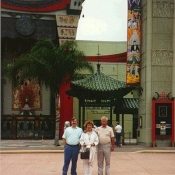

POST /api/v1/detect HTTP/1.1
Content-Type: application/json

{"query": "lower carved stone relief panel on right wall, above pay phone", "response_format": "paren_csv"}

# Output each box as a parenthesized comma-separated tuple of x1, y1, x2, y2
(152, 50, 173, 66)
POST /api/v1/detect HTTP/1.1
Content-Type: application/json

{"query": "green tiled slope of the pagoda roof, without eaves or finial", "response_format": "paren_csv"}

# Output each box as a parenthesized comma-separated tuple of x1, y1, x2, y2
(71, 72, 126, 92)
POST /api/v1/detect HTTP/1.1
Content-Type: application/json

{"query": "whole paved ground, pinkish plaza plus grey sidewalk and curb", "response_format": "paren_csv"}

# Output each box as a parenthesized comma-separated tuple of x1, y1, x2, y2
(0, 140, 175, 175)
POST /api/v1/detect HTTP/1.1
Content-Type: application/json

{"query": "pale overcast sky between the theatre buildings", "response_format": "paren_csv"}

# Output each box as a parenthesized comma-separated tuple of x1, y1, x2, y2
(76, 0, 127, 41)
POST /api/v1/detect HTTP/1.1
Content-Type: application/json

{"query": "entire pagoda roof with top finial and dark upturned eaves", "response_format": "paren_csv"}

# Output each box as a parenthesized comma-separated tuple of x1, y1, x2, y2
(66, 64, 135, 100)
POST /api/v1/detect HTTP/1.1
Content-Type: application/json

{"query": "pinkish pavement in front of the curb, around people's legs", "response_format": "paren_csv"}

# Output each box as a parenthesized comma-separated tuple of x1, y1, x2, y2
(0, 152, 175, 175)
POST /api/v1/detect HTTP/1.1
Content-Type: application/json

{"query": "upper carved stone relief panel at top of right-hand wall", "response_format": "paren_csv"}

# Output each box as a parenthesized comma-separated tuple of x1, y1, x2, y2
(153, 0, 174, 17)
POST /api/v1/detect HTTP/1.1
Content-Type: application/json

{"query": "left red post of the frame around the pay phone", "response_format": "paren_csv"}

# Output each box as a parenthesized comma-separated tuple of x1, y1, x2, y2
(152, 101, 156, 147)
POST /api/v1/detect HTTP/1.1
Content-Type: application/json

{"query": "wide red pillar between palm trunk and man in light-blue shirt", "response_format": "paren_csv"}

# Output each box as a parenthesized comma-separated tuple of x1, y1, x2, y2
(59, 83, 73, 139)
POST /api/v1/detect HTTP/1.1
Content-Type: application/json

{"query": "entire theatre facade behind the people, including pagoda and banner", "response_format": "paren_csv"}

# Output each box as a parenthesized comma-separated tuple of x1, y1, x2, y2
(1, 0, 175, 147)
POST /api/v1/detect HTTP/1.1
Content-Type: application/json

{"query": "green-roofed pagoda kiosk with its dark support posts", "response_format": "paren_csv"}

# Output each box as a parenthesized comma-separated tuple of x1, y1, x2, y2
(66, 63, 136, 126)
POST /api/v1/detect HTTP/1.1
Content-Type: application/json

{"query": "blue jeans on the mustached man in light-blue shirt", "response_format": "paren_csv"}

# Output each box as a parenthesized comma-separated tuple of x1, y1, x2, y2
(62, 145, 79, 175)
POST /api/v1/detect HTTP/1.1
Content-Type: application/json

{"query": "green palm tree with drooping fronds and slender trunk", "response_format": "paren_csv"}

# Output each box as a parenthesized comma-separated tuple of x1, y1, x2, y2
(3, 39, 93, 145)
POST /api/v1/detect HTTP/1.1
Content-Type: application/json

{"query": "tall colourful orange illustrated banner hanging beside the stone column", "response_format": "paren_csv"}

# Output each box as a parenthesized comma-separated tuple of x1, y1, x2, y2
(126, 0, 141, 84)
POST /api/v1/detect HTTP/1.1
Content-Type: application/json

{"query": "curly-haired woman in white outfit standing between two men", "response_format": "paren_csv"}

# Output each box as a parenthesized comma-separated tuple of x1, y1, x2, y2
(80, 121, 99, 175)
